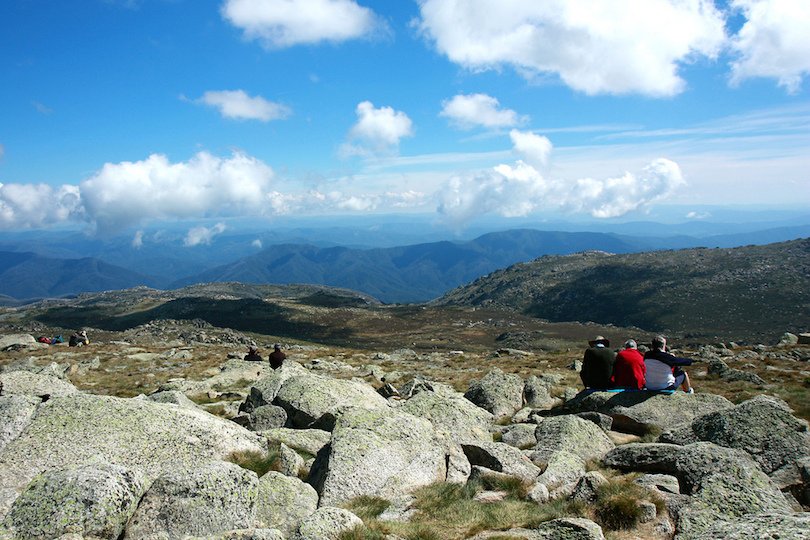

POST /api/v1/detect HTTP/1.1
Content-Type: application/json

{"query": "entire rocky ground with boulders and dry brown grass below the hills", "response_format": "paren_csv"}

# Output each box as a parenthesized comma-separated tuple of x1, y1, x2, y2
(0, 314, 810, 540)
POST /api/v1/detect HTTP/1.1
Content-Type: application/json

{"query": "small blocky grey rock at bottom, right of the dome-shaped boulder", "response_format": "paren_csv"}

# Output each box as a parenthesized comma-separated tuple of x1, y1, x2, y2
(255, 471, 318, 536)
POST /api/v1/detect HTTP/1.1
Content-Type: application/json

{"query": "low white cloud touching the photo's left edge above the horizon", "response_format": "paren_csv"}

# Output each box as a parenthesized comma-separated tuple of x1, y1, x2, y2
(0, 184, 83, 229)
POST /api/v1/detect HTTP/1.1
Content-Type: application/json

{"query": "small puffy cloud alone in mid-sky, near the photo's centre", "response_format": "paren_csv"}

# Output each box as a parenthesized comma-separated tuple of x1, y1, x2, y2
(343, 101, 413, 155)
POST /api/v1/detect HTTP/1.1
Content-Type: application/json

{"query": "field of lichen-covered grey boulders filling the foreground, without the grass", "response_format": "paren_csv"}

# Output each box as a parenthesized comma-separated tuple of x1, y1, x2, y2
(0, 350, 810, 540)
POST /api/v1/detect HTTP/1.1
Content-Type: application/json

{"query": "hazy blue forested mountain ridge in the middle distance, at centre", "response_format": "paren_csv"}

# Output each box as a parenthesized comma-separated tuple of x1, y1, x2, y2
(172, 229, 638, 302)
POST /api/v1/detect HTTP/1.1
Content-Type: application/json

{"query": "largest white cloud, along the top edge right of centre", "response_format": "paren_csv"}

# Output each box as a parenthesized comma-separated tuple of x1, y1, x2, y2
(419, 0, 726, 96)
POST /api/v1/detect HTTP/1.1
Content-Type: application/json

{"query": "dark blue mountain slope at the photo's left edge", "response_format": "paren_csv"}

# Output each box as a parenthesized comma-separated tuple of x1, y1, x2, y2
(0, 251, 158, 299)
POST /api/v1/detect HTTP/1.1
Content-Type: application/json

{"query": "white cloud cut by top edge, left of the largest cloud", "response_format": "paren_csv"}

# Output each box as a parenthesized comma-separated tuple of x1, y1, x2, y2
(222, 0, 384, 48)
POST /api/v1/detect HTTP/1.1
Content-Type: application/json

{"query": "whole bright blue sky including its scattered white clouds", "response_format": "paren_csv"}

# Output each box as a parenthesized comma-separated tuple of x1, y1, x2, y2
(0, 0, 810, 236)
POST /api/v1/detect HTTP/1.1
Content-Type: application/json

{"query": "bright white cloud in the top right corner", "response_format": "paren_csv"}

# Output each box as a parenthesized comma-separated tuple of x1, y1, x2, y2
(731, 0, 810, 93)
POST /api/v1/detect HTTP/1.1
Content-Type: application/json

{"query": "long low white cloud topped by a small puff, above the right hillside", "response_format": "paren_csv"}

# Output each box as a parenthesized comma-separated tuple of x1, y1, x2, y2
(438, 131, 684, 226)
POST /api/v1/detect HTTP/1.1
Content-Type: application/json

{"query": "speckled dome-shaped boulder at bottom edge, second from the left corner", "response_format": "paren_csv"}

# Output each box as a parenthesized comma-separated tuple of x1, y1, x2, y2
(125, 461, 259, 540)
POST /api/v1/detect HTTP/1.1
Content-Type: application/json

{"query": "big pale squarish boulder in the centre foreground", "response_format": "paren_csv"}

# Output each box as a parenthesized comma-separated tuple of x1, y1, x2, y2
(311, 408, 447, 506)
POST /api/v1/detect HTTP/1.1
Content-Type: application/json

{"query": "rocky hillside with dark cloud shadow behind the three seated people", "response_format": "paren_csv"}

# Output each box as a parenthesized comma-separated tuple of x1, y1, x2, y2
(437, 239, 810, 340)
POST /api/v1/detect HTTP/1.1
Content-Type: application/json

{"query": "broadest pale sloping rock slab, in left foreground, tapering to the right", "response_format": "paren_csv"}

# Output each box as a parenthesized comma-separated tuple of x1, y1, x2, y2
(0, 393, 266, 516)
